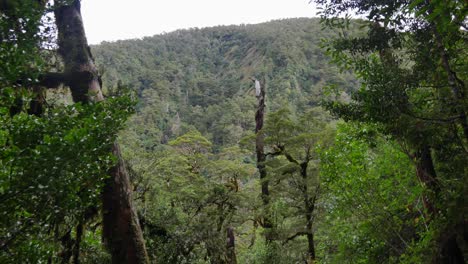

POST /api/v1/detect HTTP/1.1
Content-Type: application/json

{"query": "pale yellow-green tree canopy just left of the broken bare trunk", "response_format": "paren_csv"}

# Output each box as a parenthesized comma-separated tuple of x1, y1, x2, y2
(126, 130, 255, 263)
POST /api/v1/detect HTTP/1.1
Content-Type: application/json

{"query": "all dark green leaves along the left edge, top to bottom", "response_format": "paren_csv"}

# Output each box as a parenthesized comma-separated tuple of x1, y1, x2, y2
(0, 0, 135, 263)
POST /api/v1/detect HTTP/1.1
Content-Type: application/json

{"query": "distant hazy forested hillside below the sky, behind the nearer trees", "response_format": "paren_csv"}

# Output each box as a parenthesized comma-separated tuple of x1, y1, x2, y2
(92, 18, 357, 148)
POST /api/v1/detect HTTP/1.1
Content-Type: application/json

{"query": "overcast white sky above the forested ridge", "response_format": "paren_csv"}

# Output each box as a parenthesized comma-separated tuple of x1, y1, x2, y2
(81, 0, 316, 44)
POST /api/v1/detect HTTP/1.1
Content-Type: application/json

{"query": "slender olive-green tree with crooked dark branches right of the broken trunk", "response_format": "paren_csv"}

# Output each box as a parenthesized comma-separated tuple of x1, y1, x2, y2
(264, 108, 333, 263)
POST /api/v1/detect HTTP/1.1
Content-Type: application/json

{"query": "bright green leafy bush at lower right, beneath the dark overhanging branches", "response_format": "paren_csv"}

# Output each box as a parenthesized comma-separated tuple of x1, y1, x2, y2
(318, 123, 428, 263)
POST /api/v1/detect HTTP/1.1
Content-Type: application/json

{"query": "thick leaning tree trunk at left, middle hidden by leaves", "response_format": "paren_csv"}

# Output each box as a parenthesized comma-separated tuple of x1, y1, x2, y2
(55, 0, 149, 263)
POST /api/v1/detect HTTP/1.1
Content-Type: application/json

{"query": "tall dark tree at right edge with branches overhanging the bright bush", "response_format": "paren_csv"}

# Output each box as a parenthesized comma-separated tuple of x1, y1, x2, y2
(315, 0, 468, 263)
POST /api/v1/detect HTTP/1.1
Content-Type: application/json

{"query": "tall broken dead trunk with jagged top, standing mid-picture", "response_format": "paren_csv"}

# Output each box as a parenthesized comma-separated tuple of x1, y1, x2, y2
(254, 80, 273, 243)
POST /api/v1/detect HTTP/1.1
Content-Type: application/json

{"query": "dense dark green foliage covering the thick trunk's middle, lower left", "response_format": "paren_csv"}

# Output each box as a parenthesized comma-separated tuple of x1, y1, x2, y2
(0, 88, 132, 262)
